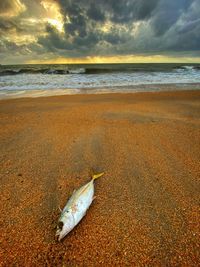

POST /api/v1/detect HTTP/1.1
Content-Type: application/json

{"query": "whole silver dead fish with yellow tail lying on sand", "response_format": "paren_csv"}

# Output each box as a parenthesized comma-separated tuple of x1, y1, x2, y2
(56, 173, 104, 241)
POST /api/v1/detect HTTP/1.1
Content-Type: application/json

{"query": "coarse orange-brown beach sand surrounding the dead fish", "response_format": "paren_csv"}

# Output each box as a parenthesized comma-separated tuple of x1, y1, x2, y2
(0, 91, 200, 266)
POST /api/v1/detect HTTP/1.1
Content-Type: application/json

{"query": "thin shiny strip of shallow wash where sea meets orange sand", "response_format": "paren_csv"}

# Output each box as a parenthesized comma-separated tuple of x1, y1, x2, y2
(0, 83, 200, 101)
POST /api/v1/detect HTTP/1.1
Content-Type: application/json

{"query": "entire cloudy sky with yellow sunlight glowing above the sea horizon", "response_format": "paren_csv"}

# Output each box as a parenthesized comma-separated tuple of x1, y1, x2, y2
(0, 0, 200, 64)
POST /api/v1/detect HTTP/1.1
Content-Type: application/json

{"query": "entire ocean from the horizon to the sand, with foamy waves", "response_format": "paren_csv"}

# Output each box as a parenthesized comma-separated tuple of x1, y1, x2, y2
(0, 63, 200, 99)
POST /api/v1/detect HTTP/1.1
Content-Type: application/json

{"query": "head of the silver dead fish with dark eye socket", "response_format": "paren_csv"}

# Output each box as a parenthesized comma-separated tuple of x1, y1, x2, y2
(56, 211, 75, 241)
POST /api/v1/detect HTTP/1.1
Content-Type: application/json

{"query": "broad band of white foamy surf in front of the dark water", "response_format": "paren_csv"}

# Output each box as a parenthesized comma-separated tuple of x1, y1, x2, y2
(0, 66, 200, 98)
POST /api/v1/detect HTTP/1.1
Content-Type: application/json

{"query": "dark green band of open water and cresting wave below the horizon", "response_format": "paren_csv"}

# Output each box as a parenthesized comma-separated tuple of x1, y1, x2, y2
(0, 64, 200, 76)
